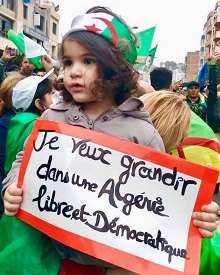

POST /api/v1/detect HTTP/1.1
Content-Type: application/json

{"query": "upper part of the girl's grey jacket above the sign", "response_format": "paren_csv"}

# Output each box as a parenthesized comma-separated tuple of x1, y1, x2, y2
(42, 98, 164, 151)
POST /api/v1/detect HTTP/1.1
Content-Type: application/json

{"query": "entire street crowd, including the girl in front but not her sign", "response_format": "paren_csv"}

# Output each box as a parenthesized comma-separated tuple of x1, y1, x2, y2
(0, 6, 220, 275)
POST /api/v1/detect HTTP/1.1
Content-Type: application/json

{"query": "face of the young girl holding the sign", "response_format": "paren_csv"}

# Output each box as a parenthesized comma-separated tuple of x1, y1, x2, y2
(62, 40, 99, 103)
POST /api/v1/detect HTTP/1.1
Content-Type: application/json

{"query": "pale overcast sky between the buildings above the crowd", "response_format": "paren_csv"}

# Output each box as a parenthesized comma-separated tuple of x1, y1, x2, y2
(53, 0, 217, 65)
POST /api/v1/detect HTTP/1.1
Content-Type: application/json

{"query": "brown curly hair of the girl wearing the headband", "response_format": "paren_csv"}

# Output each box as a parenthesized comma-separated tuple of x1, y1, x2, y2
(54, 7, 139, 105)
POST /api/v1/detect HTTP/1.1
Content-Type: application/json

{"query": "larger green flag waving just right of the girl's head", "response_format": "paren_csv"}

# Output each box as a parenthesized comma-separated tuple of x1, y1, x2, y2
(136, 26, 156, 59)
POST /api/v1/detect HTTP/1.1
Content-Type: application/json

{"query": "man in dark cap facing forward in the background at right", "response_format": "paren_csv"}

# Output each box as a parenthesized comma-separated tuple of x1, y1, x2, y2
(186, 81, 207, 122)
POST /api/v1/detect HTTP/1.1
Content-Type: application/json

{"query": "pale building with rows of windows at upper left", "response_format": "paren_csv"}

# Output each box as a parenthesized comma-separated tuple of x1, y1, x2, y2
(0, 0, 60, 59)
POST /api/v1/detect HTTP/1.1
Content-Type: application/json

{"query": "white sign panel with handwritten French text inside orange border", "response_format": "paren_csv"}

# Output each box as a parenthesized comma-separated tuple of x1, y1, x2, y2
(17, 121, 218, 272)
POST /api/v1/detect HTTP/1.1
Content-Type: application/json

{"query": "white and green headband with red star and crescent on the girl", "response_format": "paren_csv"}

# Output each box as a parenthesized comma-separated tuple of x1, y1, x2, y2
(64, 13, 137, 64)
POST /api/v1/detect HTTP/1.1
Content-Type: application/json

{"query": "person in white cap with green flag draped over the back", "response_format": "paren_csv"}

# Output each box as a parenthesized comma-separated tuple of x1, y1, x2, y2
(4, 70, 55, 177)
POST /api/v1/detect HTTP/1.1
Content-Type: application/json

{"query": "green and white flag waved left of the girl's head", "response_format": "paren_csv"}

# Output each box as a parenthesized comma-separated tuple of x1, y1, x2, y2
(7, 29, 47, 69)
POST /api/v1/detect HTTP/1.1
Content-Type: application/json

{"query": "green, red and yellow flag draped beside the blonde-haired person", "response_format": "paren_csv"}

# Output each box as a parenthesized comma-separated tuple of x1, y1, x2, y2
(172, 111, 220, 182)
